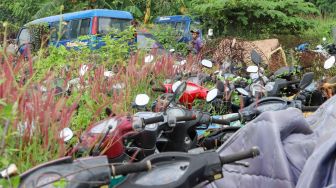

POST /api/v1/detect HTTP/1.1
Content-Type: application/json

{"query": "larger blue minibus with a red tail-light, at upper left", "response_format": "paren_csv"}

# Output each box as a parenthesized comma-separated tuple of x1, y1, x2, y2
(17, 9, 133, 53)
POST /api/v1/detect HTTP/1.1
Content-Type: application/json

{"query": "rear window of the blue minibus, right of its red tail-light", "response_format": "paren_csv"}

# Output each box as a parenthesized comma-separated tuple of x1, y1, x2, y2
(98, 18, 131, 34)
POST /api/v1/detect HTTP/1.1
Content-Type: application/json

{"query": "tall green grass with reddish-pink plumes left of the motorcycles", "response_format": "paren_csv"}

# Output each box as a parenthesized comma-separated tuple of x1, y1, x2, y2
(0, 40, 193, 176)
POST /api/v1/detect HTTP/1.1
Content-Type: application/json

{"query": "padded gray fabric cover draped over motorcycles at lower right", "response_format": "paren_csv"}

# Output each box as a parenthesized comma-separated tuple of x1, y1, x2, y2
(207, 97, 336, 188)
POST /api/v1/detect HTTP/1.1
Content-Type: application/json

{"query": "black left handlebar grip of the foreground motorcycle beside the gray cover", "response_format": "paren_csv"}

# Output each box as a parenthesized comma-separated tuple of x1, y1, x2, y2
(111, 160, 152, 176)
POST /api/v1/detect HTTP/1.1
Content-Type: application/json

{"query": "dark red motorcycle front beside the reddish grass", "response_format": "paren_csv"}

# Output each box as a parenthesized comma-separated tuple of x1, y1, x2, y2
(68, 112, 163, 161)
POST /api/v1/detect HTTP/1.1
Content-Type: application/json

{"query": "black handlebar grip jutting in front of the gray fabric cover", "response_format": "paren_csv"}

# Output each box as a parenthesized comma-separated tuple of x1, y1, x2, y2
(220, 146, 260, 165)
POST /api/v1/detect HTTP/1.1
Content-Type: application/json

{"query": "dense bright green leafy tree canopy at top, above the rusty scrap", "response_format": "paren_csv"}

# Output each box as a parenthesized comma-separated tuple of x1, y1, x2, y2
(192, 0, 318, 36)
